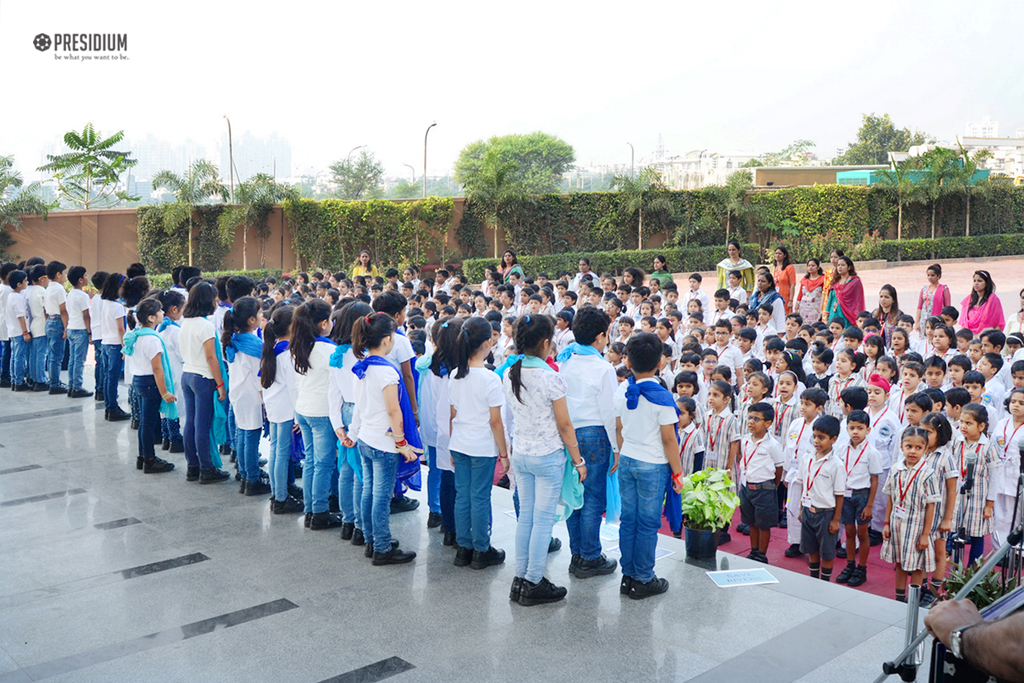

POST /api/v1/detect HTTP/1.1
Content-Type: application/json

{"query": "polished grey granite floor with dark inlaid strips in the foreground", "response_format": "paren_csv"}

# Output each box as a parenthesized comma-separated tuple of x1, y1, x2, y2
(0, 390, 927, 683)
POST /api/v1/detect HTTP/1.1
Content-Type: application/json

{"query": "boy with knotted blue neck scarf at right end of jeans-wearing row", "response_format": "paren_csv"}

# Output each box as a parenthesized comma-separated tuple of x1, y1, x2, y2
(614, 333, 683, 600)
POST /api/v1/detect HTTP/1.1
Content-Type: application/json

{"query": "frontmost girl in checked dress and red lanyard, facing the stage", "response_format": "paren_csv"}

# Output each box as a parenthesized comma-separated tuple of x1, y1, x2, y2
(882, 427, 939, 602)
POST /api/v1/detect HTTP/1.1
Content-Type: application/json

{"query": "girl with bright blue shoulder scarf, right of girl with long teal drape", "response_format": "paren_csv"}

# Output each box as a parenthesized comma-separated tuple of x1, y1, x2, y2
(221, 296, 270, 496)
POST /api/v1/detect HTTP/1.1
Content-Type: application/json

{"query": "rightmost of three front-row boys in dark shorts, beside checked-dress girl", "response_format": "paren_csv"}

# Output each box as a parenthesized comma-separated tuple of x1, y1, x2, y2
(836, 410, 882, 586)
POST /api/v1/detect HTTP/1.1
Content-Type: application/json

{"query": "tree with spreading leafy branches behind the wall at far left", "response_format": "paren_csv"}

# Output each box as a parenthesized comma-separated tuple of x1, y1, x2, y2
(38, 123, 139, 211)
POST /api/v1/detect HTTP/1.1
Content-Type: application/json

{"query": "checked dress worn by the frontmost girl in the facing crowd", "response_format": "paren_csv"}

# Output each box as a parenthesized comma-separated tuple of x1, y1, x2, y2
(882, 457, 939, 571)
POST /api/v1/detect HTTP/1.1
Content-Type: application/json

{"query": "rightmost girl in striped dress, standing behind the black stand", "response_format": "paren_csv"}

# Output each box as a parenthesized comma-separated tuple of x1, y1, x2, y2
(953, 403, 1000, 564)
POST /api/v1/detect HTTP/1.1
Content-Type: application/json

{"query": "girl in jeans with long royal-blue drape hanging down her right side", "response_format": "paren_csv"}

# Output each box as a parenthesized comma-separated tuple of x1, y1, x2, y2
(347, 313, 423, 565)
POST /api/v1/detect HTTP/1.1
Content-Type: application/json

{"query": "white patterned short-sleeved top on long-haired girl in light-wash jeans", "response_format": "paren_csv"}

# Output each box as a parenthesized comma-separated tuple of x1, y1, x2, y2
(502, 368, 567, 458)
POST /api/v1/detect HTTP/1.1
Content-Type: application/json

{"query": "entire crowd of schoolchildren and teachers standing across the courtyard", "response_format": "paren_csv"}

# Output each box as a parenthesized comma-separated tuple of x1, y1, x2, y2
(0, 243, 1024, 605)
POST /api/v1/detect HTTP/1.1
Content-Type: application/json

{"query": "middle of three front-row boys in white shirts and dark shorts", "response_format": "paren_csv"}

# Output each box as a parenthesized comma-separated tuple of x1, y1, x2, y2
(797, 415, 846, 581)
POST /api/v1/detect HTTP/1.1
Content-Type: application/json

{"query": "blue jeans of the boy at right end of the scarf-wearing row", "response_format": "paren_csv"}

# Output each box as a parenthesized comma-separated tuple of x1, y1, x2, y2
(614, 456, 670, 584)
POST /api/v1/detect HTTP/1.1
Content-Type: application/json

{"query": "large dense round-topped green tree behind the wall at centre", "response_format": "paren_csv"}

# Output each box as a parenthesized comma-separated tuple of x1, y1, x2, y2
(455, 131, 575, 195)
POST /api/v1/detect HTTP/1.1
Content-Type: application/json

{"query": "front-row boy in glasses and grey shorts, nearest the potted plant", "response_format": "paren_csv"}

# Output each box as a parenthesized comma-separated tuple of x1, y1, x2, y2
(737, 401, 783, 564)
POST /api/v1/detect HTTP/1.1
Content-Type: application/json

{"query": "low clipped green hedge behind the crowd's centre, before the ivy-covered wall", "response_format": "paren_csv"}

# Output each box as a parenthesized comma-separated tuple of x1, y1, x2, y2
(462, 244, 761, 283)
